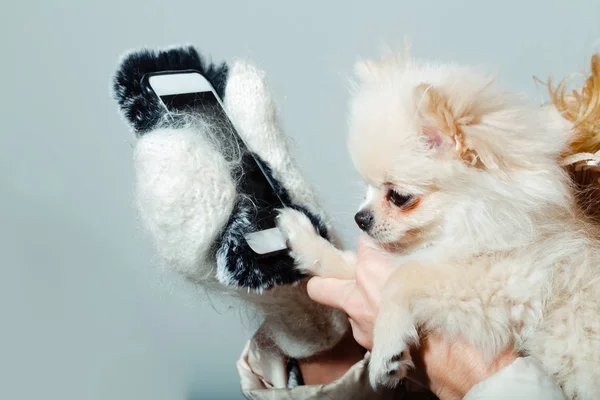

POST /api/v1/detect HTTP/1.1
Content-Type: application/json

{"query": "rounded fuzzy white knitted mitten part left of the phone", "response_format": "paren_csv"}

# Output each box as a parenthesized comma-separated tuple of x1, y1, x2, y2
(134, 128, 236, 283)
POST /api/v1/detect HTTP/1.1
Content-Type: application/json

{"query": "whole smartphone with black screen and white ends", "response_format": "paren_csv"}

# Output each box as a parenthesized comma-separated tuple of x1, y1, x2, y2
(143, 70, 287, 256)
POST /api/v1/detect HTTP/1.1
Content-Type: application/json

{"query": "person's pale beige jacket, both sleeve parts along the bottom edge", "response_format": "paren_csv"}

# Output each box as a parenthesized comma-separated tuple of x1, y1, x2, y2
(237, 330, 564, 400)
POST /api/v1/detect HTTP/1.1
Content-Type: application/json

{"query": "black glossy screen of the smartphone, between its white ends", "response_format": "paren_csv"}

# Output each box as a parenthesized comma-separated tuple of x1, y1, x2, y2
(160, 91, 284, 230)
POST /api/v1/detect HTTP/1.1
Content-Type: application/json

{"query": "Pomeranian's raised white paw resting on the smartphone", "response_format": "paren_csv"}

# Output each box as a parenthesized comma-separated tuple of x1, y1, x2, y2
(277, 208, 323, 273)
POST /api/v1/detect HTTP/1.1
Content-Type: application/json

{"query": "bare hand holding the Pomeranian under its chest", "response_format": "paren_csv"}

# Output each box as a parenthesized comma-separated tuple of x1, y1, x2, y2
(307, 237, 518, 400)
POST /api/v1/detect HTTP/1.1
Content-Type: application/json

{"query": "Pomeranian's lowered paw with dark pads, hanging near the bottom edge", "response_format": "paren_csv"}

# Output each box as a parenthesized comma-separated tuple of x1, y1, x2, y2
(369, 343, 414, 389)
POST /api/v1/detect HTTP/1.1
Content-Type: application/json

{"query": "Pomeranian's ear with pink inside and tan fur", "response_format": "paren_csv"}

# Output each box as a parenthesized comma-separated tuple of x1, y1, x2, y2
(414, 83, 496, 168)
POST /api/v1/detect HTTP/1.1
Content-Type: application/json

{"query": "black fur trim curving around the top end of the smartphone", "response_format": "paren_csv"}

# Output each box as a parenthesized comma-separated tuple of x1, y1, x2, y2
(113, 46, 228, 135)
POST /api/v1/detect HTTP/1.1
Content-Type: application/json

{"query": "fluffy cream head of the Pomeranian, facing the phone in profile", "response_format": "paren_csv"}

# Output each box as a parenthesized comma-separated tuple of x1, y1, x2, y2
(349, 51, 572, 252)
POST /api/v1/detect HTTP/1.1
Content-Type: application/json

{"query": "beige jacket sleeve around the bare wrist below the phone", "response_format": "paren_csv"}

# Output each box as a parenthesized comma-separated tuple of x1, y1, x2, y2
(237, 332, 434, 400)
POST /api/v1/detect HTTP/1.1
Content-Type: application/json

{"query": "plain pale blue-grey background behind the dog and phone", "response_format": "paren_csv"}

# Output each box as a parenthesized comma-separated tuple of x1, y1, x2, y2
(0, 0, 600, 400)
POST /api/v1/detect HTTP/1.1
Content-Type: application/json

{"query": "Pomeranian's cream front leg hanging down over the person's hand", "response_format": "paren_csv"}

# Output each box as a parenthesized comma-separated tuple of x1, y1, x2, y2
(369, 263, 515, 387)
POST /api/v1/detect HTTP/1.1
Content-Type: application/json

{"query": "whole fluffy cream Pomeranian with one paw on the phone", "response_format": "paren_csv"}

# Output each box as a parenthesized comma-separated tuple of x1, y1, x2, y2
(279, 51, 600, 399)
